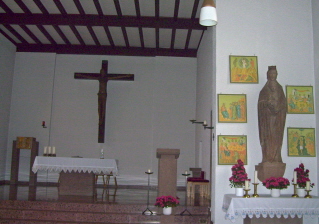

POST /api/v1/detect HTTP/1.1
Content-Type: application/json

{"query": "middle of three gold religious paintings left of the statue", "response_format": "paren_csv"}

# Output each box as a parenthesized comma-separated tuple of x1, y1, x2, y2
(218, 94, 247, 123)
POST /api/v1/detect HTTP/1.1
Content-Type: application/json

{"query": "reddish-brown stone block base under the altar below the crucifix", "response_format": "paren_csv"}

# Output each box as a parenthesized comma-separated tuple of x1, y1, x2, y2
(59, 171, 95, 196)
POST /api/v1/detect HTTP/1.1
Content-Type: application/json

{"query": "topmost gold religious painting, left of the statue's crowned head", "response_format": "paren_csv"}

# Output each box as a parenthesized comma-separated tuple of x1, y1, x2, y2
(229, 55, 258, 83)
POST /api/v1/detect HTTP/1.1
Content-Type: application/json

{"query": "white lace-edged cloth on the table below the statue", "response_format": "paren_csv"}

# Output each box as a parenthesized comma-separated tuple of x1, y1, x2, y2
(223, 194, 319, 222)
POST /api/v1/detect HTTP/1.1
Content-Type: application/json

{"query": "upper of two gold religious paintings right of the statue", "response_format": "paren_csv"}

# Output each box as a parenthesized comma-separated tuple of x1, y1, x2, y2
(286, 86, 315, 114)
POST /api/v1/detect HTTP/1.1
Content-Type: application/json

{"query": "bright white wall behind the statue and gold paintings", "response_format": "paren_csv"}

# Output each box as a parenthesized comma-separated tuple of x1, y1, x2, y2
(213, 0, 318, 224)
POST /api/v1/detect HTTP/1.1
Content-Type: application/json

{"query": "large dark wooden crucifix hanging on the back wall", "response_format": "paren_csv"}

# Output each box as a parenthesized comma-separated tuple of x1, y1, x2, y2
(74, 60, 134, 143)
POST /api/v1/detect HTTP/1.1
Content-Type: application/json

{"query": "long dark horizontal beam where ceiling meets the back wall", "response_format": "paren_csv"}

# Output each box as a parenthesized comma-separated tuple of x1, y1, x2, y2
(16, 44, 197, 57)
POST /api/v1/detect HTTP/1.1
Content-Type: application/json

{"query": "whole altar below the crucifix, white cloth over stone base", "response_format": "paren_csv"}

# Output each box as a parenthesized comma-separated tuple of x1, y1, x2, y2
(32, 156, 118, 196)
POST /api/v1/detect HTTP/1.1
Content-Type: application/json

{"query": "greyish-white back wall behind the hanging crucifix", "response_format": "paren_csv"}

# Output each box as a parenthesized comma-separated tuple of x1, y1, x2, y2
(7, 53, 196, 185)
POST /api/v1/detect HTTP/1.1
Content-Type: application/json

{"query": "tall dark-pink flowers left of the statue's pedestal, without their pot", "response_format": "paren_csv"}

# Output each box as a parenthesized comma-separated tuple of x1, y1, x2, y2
(229, 159, 250, 187)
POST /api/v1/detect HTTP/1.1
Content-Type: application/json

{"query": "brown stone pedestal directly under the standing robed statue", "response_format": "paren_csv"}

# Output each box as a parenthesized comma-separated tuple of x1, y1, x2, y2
(255, 162, 286, 181)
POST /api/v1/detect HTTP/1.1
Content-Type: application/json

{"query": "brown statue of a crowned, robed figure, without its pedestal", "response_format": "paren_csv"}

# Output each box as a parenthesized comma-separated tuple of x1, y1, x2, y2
(258, 66, 287, 163)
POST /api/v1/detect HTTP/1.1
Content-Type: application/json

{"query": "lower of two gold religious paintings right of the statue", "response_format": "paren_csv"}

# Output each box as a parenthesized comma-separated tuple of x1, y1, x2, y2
(287, 128, 316, 157)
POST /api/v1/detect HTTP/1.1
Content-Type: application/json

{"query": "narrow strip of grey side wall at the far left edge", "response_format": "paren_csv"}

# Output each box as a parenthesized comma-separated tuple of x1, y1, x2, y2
(0, 34, 16, 180)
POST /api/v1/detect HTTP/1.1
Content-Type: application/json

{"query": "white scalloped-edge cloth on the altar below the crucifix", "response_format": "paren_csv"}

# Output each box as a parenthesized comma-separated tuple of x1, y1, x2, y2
(32, 156, 118, 176)
